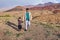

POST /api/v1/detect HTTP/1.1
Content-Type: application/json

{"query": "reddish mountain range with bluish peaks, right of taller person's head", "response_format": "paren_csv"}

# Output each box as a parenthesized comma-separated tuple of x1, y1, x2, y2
(30, 2, 60, 10)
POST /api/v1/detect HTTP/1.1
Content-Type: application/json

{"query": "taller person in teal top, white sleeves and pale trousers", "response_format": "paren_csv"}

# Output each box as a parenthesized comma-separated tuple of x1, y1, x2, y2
(24, 8, 32, 31)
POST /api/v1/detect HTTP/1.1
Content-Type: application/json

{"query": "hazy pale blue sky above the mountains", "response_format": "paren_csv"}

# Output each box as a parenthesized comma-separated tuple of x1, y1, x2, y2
(0, 0, 60, 9)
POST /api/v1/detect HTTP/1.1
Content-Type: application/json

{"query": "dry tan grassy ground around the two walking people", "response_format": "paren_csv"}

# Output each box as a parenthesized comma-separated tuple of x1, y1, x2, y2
(0, 10, 60, 40)
